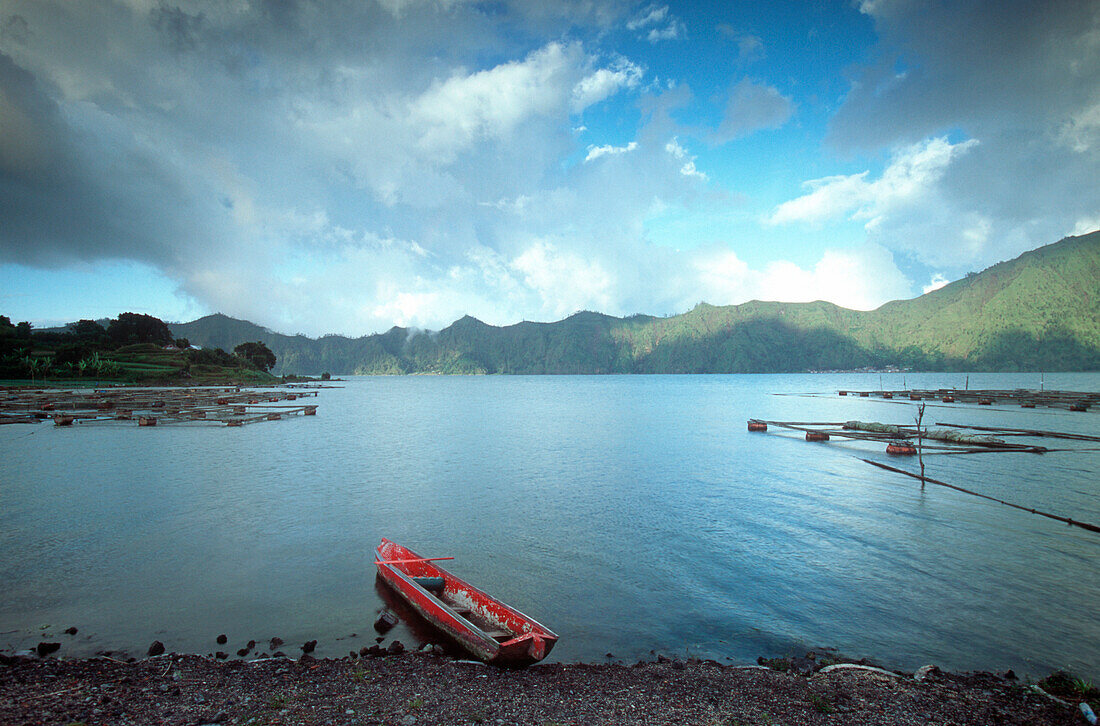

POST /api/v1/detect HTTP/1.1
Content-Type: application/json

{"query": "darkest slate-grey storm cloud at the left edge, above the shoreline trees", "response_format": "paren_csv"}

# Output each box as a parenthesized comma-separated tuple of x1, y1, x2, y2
(0, 48, 228, 266)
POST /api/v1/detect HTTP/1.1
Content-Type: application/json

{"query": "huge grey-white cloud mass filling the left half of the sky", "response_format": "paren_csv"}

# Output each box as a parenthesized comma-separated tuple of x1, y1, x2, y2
(0, 0, 684, 329)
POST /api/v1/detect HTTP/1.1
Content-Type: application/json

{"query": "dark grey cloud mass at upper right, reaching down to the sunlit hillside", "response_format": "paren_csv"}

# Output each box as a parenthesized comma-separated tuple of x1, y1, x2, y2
(828, 0, 1100, 268)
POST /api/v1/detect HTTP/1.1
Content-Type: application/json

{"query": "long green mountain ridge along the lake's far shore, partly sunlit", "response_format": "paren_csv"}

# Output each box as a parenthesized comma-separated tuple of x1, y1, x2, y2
(171, 232, 1100, 374)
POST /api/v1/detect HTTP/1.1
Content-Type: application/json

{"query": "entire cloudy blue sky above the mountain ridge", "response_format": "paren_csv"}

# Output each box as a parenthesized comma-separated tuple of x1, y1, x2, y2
(0, 0, 1100, 337)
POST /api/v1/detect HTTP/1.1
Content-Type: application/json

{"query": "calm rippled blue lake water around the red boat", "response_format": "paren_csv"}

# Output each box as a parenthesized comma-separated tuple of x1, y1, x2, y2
(0, 374, 1100, 679)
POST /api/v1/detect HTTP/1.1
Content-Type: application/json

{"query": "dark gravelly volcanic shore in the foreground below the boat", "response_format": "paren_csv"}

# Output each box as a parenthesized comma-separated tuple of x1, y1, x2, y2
(0, 653, 1085, 726)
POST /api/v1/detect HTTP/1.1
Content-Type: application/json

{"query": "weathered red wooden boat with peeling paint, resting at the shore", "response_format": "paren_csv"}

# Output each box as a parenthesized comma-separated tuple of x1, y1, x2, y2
(375, 538, 558, 667)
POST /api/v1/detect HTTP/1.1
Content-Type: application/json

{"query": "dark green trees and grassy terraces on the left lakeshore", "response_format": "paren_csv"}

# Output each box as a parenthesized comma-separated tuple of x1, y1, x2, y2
(0, 312, 275, 385)
